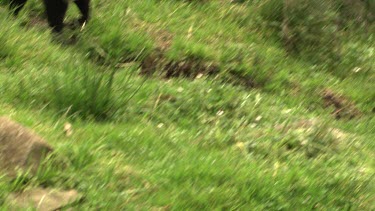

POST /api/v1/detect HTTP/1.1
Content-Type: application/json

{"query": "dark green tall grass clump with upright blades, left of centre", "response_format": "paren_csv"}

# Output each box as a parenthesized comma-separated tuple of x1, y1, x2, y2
(47, 66, 144, 121)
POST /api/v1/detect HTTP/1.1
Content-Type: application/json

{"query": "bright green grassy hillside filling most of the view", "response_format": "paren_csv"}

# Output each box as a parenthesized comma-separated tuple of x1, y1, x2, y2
(0, 0, 375, 210)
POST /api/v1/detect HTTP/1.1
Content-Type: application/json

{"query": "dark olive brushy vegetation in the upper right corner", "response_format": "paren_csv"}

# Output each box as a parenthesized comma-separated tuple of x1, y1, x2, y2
(256, 0, 374, 74)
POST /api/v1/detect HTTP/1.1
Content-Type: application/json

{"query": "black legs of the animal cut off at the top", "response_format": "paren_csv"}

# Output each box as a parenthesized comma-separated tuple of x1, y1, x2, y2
(10, 0, 90, 32)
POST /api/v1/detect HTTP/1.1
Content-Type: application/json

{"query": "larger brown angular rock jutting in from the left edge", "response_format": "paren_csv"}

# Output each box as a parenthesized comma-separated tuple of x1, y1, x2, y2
(0, 117, 52, 177)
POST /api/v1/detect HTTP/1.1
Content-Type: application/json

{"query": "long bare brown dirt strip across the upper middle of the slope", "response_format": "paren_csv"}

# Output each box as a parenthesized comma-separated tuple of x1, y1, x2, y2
(121, 15, 263, 88)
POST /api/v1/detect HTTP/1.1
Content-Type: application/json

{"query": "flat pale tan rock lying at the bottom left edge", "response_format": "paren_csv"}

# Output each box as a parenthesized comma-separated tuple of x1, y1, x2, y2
(5, 188, 82, 211)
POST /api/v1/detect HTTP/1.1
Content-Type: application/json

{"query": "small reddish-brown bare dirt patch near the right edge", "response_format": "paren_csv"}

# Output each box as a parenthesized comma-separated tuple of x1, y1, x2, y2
(321, 89, 361, 119)
